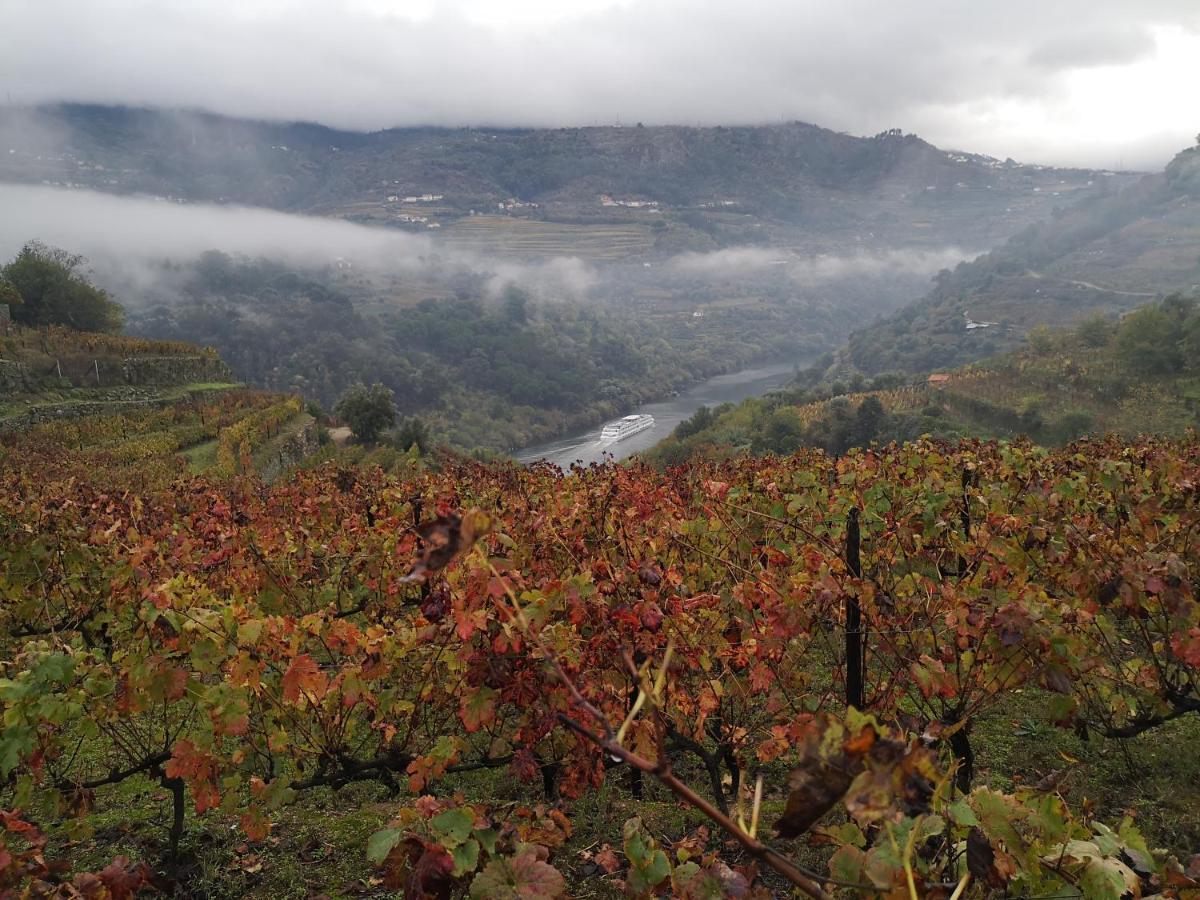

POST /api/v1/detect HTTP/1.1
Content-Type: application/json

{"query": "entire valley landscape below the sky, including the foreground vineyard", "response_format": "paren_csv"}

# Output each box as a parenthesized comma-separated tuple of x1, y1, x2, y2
(0, 90, 1200, 900)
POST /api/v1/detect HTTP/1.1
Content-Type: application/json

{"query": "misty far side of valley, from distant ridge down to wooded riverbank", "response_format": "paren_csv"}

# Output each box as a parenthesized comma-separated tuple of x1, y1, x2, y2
(0, 104, 1152, 452)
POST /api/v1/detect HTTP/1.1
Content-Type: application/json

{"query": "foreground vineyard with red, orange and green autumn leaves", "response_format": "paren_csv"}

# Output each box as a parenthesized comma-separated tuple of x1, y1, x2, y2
(0, 438, 1200, 900)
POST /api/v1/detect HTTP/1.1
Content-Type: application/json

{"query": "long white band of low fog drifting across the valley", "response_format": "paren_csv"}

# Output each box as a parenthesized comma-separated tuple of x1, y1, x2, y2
(0, 184, 968, 312)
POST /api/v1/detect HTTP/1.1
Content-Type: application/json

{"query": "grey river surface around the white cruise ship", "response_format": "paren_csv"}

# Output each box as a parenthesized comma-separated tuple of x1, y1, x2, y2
(515, 361, 803, 469)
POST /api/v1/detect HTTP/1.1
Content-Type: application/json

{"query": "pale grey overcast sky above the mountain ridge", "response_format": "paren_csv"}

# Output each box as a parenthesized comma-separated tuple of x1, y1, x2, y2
(0, 0, 1200, 168)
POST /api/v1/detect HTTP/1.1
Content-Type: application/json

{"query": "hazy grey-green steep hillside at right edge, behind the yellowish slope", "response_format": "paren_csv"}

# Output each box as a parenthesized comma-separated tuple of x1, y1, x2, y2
(845, 148, 1200, 374)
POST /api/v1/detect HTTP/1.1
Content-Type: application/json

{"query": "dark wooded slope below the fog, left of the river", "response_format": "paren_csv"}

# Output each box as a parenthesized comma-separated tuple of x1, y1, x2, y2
(121, 253, 842, 450)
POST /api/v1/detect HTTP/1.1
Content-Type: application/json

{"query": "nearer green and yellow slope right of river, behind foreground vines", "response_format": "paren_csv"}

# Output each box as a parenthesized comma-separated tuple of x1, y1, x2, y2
(647, 294, 1200, 464)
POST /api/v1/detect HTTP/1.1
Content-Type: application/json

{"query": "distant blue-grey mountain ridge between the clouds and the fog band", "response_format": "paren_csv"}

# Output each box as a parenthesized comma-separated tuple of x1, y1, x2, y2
(0, 104, 1129, 252)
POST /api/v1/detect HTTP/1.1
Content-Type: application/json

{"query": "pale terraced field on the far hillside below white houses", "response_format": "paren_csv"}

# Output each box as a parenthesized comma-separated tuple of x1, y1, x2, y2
(442, 216, 654, 259)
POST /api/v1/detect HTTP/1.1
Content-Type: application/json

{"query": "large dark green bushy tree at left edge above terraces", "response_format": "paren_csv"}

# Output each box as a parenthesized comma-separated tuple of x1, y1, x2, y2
(0, 241, 125, 331)
